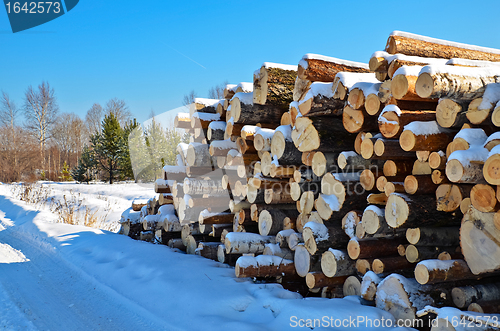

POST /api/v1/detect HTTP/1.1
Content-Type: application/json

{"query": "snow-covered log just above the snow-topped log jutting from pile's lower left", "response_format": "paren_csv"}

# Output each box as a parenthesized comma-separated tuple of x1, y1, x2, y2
(224, 232, 276, 254)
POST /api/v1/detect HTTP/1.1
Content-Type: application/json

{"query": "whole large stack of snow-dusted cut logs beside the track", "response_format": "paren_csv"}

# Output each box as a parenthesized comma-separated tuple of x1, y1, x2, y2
(122, 32, 500, 330)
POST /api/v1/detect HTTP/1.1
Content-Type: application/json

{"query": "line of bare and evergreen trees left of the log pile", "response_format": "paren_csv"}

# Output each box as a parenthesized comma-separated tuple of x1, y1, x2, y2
(0, 82, 187, 183)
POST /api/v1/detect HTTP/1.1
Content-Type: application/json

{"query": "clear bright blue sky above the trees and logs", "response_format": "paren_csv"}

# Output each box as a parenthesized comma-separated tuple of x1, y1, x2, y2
(0, 0, 500, 122)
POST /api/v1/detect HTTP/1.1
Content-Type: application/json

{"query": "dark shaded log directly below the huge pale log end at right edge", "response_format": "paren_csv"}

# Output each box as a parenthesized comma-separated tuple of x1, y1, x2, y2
(451, 283, 500, 308)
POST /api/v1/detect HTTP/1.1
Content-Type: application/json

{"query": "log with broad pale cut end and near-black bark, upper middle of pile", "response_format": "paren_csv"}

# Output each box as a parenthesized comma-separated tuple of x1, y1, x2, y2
(292, 116, 355, 152)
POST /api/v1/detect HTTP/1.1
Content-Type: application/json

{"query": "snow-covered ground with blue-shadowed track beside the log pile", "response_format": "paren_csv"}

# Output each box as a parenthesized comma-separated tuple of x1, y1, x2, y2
(0, 183, 418, 331)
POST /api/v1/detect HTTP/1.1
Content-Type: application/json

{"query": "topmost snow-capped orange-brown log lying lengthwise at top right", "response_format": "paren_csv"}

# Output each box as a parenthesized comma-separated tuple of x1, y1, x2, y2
(385, 31, 500, 61)
